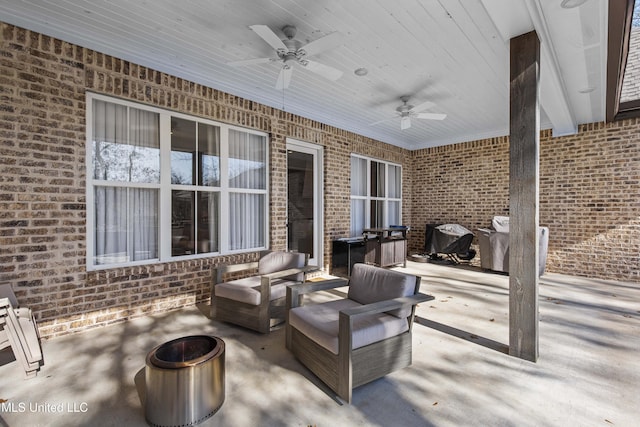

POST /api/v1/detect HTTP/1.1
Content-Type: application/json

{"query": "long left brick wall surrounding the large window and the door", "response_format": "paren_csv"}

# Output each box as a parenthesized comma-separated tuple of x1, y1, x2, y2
(0, 23, 406, 337)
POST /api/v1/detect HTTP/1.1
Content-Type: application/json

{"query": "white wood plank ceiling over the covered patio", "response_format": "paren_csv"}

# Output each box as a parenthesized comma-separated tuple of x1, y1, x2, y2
(0, 0, 608, 149)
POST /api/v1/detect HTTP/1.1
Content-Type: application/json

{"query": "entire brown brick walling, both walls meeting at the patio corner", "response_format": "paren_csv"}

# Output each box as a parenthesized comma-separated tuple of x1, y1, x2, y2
(0, 23, 640, 337)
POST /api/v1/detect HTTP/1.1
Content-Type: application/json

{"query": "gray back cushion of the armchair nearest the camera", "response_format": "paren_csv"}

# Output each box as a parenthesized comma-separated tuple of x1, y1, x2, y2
(348, 264, 416, 317)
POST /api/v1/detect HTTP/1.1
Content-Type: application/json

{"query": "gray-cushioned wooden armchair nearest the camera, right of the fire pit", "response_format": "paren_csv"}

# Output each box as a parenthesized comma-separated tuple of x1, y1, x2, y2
(286, 264, 433, 403)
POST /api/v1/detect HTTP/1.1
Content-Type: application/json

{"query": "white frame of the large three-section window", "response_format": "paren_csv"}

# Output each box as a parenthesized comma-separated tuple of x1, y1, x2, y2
(85, 92, 270, 271)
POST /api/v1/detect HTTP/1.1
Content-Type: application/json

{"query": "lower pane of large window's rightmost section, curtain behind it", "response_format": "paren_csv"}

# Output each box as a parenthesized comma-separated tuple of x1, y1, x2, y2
(229, 193, 265, 250)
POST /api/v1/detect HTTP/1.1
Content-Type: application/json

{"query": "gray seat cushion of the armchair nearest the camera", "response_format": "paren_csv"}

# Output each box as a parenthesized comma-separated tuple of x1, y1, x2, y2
(289, 298, 409, 354)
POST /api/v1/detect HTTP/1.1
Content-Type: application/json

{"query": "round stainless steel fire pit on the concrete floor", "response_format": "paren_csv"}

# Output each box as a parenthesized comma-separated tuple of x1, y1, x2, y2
(145, 335, 225, 427)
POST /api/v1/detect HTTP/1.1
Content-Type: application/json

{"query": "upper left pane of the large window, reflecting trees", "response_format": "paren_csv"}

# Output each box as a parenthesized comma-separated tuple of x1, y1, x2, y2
(92, 100, 160, 183)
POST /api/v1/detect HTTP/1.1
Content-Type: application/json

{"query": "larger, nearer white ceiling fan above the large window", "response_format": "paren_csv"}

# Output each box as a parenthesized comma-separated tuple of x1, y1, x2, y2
(227, 25, 342, 89)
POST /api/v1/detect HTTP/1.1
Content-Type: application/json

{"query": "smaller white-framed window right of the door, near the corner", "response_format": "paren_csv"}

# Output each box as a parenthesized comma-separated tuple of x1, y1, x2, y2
(351, 155, 402, 236)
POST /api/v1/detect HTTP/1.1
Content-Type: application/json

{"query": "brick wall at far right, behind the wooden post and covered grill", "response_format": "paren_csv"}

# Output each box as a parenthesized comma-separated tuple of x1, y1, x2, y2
(410, 125, 640, 282)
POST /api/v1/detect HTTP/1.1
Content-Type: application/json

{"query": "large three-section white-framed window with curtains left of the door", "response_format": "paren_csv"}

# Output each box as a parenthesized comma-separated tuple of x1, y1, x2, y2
(87, 94, 268, 269)
